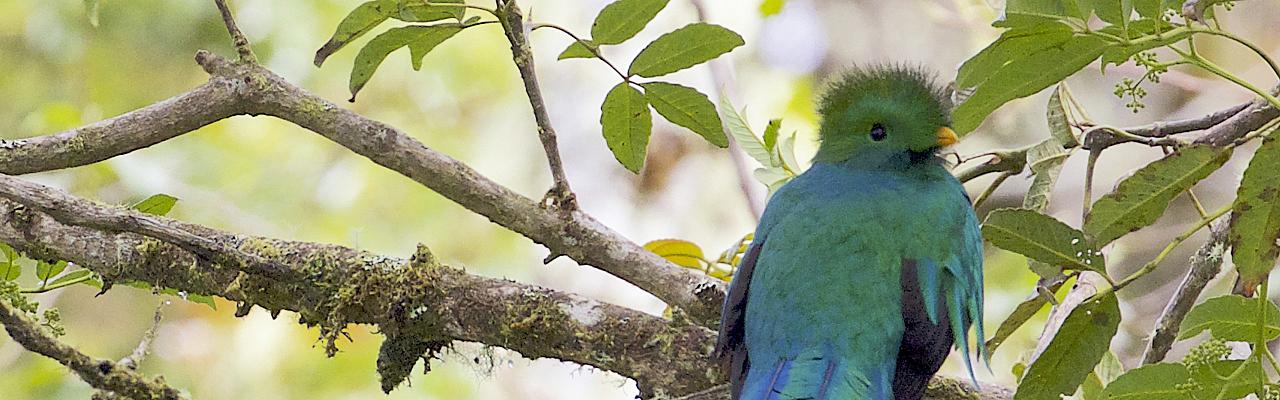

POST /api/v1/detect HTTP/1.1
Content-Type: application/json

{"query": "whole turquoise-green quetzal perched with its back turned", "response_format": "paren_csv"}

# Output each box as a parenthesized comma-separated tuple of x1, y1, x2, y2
(716, 67, 986, 400)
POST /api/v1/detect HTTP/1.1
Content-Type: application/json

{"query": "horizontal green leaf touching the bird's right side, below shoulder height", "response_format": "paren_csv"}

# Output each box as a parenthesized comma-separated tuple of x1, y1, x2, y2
(982, 209, 1106, 276)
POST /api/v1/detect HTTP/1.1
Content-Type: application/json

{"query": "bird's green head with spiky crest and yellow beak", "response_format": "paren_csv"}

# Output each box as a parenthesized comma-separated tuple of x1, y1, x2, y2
(814, 67, 956, 163)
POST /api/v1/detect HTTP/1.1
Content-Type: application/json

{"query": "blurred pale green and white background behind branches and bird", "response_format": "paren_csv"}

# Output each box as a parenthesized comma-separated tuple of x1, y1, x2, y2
(0, 0, 1280, 399)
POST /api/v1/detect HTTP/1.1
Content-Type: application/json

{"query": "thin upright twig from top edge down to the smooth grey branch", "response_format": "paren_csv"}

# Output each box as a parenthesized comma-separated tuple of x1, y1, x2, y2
(497, 0, 577, 211)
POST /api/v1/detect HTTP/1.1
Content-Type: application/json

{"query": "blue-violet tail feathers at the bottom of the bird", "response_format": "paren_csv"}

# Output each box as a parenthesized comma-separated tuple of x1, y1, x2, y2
(740, 353, 893, 400)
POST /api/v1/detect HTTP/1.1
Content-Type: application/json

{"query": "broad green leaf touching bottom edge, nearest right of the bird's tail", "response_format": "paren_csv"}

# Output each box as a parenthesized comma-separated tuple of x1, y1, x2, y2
(1014, 292, 1120, 400)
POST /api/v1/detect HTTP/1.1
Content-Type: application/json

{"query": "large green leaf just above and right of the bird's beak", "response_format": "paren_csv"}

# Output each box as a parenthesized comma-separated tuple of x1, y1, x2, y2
(952, 24, 1107, 133)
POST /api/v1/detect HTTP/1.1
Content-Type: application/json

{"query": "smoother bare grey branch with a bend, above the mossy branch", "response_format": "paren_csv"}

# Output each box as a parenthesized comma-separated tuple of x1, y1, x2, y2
(0, 51, 724, 326)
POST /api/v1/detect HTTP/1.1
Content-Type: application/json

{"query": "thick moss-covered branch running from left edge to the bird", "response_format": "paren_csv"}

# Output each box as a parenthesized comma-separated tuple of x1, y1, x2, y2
(0, 178, 723, 394)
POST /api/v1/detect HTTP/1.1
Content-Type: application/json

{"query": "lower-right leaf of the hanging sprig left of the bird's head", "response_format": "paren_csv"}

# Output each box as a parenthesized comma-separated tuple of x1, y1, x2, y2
(640, 82, 728, 147)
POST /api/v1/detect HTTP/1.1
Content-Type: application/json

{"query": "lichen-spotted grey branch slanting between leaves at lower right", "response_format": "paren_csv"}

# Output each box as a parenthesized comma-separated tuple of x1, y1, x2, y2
(1142, 215, 1231, 364)
